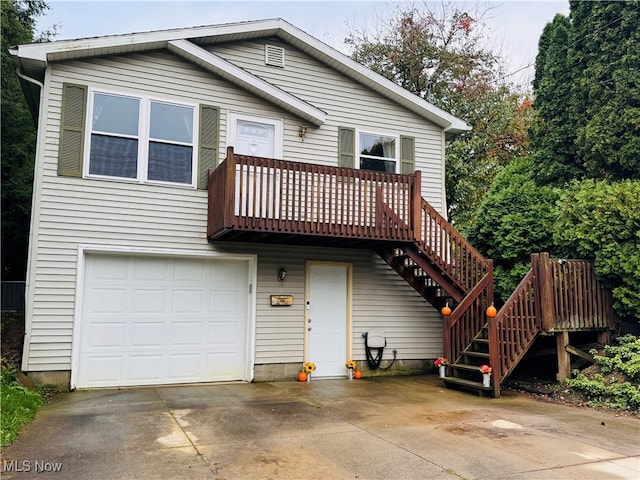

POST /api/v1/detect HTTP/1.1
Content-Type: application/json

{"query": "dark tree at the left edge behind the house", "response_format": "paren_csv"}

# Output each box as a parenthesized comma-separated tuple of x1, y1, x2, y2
(0, 0, 52, 280)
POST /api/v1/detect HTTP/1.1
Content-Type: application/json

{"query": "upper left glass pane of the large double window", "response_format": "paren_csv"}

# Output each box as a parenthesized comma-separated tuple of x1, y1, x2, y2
(92, 93, 140, 136)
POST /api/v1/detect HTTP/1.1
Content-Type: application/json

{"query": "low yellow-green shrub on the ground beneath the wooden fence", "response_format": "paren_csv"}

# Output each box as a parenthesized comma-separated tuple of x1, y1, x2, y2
(567, 335, 640, 410)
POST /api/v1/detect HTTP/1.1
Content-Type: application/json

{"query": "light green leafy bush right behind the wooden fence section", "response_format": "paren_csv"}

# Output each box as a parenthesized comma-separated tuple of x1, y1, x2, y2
(554, 180, 640, 320)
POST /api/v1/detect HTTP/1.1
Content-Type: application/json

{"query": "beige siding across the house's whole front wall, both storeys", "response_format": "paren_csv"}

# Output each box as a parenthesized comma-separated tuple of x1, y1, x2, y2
(23, 42, 442, 378)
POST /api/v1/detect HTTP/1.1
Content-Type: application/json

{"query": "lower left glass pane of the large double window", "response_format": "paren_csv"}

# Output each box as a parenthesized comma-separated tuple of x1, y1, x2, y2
(89, 134, 138, 178)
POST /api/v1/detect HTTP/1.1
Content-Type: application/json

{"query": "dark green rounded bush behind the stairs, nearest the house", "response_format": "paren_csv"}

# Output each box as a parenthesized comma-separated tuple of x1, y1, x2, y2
(468, 157, 558, 301)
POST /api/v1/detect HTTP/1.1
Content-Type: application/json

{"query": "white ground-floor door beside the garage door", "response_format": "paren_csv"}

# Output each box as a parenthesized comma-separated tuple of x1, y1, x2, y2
(307, 264, 348, 377)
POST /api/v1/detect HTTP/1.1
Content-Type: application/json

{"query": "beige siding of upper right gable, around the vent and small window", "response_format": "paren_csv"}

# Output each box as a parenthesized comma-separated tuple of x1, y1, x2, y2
(209, 39, 444, 213)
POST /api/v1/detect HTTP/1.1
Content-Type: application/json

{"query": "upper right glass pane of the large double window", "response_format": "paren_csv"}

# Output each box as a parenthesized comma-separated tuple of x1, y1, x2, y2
(149, 102, 193, 143)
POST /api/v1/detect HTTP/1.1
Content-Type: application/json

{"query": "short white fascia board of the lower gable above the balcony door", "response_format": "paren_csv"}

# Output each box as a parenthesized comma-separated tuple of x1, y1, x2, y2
(167, 40, 326, 127)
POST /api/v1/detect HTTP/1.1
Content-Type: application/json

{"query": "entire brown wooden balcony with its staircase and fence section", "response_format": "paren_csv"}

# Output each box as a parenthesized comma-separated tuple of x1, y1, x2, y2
(207, 153, 613, 396)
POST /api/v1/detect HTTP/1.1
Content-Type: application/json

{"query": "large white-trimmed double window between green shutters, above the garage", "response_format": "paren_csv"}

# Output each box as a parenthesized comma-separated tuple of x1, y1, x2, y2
(85, 92, 197, 185)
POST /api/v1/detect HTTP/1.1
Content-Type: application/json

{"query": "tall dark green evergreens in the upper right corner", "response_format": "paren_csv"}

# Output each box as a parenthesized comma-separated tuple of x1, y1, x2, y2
(531, 0, 640, 185)
